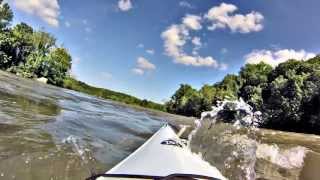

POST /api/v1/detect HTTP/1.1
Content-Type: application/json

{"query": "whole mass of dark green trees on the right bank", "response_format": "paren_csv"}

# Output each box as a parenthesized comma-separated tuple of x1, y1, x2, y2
(166, 56, 320, 134)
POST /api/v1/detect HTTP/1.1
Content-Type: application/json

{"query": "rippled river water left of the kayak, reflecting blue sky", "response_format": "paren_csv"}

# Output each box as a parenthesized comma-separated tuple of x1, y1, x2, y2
(0, 72, 162, 180)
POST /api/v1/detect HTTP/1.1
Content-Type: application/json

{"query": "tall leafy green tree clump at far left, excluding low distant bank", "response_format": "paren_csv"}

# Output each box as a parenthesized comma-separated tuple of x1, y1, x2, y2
(0, 0, 71, 86)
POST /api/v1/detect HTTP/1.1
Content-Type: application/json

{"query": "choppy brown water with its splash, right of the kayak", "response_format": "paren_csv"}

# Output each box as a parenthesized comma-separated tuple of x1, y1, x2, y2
(190, 99, 320, 180)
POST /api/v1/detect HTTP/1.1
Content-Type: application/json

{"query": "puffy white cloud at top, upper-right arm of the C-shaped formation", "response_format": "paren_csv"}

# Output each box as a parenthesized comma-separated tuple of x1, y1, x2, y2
(205, 3, 264, 33)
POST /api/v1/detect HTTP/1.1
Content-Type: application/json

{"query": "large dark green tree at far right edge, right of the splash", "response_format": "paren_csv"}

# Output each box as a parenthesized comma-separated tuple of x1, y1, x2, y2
(262, 57, 320, 134)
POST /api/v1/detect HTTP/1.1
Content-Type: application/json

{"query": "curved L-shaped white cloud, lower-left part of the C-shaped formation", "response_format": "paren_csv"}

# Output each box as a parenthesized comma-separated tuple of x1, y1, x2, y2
(161, 25, 218, 68)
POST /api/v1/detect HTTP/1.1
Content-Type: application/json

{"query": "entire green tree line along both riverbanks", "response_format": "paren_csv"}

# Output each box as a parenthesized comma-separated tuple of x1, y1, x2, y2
(0, 0, 320, 134)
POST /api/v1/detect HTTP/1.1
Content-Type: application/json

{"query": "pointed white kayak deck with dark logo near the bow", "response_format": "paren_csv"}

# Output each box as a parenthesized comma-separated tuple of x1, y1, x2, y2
(95, 125, 225, 180)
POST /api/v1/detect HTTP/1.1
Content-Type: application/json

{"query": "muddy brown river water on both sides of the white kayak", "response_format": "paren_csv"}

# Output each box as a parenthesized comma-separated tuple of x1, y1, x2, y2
(0, 71, 320, 180)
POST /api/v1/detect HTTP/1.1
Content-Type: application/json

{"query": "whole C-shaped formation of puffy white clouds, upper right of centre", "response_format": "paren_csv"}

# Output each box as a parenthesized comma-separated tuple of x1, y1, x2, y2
(161, 3, 264, 70)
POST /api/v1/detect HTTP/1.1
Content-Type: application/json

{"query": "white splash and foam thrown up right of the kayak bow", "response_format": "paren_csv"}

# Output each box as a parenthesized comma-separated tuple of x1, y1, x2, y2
(189, 99, 308, 180)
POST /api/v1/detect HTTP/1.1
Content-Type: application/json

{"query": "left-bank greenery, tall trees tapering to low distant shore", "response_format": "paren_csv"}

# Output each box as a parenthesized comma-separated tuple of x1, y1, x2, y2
(0, 0, 165, 111)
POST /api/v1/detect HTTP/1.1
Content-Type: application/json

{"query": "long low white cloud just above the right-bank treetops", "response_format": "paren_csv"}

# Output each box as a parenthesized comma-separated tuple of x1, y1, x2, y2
(244, 49, 316, 67)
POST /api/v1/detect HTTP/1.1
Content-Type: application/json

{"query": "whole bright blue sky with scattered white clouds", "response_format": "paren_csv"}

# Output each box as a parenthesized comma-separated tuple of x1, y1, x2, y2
(9, 0, 320, 102)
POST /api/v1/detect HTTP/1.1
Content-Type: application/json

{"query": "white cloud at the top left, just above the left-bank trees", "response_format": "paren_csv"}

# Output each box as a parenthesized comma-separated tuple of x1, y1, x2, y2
(13, 0, 60, 27)
